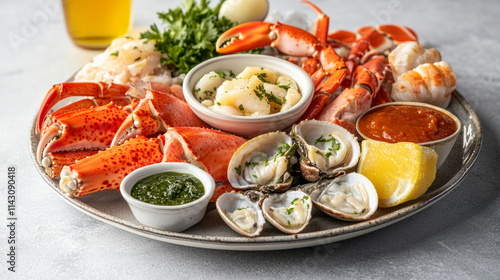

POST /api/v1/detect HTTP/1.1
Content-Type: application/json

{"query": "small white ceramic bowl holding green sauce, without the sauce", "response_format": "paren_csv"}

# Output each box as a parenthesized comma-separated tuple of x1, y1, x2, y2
(120, 162, 215, 232)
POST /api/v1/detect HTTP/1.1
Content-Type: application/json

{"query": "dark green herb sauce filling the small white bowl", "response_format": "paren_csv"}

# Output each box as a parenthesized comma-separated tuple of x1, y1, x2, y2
(130, 172, 205, 205)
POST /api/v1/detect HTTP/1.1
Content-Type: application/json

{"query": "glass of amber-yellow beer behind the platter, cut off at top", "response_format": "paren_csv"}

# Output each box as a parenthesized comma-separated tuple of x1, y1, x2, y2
(62, 0, 132, 49)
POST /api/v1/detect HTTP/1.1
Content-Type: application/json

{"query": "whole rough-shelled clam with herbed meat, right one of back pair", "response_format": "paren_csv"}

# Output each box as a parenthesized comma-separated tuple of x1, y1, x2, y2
(291, 120, 360, 182)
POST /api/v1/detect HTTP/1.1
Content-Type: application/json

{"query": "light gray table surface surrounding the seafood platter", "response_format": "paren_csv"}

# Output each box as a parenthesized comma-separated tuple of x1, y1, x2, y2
(0, 0, 500, 279)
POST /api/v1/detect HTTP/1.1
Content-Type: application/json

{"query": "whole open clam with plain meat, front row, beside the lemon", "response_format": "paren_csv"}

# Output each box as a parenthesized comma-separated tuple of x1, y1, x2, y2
(310, 173, 378, 221)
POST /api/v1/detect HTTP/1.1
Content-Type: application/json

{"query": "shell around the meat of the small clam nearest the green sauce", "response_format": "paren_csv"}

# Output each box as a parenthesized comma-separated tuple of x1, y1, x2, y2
(215, 192, 266, 237)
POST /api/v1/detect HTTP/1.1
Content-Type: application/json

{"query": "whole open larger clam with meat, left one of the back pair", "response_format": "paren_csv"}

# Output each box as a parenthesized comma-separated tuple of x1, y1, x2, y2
(227, 132, 296, 192)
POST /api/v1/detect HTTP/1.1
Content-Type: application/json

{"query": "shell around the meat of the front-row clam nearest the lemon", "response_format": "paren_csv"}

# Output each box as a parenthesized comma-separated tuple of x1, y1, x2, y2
(311, 172, 378, 221)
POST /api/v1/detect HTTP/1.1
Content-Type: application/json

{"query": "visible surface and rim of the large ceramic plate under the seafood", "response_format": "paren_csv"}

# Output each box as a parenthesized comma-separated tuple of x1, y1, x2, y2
(29, 91, 482, 251)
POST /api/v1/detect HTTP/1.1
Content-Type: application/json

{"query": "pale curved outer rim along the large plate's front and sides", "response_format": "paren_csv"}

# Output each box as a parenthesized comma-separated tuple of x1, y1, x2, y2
(29, 90, 483, 251)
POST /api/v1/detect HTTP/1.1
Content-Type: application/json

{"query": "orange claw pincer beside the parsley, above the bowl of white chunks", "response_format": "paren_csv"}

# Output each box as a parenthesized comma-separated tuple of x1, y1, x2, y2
(215, 21, 275, 54)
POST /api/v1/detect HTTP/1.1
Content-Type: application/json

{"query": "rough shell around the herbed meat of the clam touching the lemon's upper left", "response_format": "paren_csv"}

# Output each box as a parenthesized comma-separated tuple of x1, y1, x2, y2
(291, 120, 361, 182)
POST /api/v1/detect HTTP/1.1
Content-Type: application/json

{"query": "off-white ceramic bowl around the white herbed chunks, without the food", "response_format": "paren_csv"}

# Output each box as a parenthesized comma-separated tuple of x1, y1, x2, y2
(182, 54, 314, 138)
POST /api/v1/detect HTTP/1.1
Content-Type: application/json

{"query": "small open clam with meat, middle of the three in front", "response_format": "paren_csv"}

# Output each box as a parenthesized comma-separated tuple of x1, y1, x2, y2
(262, 191, 312, 234)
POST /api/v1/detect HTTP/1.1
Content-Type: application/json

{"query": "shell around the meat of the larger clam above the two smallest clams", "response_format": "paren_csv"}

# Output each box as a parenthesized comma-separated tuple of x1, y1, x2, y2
(227, 132, 295, 192)
